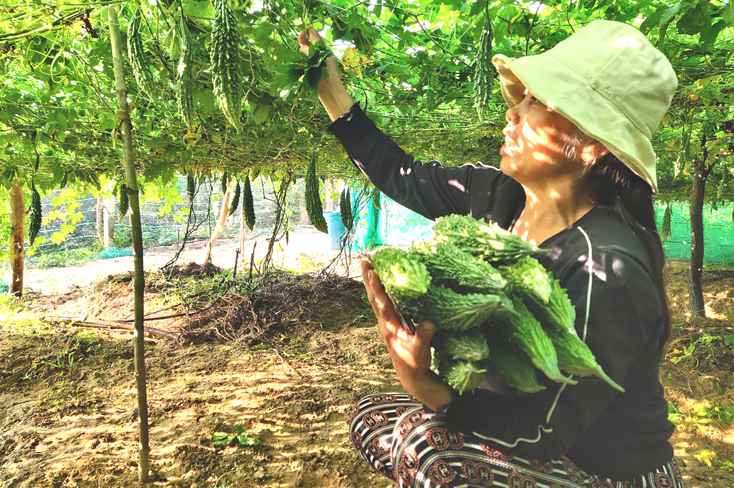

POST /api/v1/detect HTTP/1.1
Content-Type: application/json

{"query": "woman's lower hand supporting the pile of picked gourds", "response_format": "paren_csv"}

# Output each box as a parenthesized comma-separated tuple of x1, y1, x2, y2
(362, 260, 451, 410)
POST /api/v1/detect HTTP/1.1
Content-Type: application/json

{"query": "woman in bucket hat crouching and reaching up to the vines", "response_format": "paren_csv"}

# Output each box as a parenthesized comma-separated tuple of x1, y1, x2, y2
(299, 21, 683, 488)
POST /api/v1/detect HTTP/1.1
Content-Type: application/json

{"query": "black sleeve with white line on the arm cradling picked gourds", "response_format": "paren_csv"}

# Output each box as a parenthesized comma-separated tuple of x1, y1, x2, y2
(445, 246, 662, 461)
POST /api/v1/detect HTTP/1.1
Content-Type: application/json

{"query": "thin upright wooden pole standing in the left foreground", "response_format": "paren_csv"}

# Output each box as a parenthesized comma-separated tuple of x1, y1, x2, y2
(107, 6, 150, 482)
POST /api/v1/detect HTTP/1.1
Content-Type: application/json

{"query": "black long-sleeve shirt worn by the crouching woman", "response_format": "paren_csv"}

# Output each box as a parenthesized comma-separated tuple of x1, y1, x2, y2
(329, 105, 673, 480)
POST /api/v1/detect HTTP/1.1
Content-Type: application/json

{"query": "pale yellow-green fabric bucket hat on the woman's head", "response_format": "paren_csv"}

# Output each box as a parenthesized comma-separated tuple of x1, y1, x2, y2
(492, 20, 678, 192)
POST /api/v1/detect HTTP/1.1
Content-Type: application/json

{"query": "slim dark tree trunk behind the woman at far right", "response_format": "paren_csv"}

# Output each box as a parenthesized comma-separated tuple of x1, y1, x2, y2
(688, 161, 708, 317)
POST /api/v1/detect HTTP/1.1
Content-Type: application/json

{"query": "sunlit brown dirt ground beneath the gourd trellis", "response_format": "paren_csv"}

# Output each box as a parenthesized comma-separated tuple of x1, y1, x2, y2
(0, 237, 734, 488)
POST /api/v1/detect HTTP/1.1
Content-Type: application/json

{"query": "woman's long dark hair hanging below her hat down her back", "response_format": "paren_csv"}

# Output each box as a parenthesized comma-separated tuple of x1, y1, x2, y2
(587, 153, 670, 355)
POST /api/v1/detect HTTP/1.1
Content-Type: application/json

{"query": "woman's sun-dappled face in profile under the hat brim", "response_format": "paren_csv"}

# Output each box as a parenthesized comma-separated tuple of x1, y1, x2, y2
(500, 90, 583, 186)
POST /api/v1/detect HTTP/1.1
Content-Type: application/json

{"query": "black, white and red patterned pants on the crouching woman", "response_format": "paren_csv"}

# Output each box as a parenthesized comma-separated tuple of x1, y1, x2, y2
(349, 393, 683, 488)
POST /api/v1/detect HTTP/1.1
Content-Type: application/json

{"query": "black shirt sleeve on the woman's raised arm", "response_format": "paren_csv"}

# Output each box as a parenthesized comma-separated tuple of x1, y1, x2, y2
(329, 104, 500, 220)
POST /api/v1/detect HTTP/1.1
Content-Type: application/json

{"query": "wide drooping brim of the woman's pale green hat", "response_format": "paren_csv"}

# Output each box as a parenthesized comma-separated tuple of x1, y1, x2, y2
(492, 51, 657, 193)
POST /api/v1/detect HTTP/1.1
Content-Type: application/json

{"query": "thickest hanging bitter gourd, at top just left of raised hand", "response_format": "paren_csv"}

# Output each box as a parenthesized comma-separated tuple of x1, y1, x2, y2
(209, 0, 242, 131)
